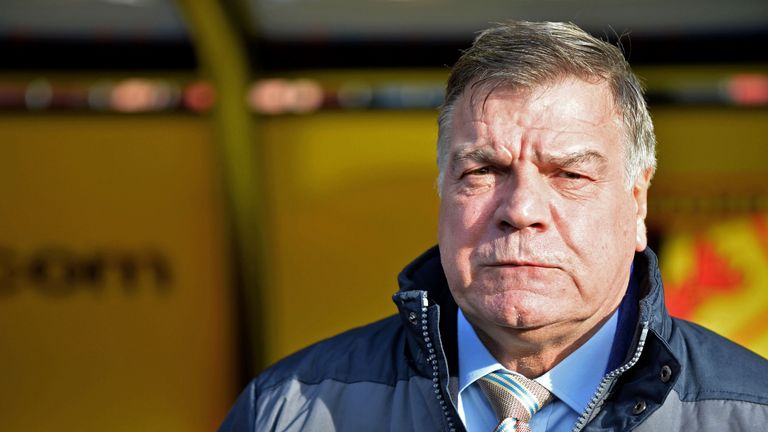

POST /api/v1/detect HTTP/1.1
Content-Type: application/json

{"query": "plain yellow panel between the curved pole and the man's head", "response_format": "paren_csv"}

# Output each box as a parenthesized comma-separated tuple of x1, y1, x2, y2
(262, 111, 438, 362)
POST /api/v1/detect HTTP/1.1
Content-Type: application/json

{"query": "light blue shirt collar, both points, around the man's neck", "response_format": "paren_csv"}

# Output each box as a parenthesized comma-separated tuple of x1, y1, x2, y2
(457, 309, 618, 413)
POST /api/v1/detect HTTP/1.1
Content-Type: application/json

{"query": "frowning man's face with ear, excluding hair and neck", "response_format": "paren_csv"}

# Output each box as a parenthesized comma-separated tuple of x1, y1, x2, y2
(439, 78, 648, 340)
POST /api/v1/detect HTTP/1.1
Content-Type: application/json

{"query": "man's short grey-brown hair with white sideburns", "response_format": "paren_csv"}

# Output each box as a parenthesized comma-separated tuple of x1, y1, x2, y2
(437, 21, 656, 191)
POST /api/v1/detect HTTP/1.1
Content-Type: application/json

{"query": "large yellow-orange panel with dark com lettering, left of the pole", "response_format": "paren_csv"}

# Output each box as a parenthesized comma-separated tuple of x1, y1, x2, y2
(0, 115, 237, 432)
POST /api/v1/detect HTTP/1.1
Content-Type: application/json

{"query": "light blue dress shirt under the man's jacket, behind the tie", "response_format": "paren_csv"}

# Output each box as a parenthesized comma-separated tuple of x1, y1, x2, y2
(457, 309, 618, 432)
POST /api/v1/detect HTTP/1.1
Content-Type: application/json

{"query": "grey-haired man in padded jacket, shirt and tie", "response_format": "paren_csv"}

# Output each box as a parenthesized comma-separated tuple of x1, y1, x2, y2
(222, 22, 768, 431)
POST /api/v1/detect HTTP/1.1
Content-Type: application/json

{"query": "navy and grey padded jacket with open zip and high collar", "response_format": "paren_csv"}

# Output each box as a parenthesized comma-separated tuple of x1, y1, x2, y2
(220, 247, 768, 432)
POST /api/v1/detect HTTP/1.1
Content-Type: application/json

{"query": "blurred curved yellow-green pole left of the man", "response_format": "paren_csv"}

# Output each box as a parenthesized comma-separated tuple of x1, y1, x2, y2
(178, 0, 266, 374)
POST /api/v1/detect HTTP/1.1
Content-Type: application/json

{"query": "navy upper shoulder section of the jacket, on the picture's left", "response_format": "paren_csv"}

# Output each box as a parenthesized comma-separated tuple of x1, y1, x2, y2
(253, 315, 404, 391)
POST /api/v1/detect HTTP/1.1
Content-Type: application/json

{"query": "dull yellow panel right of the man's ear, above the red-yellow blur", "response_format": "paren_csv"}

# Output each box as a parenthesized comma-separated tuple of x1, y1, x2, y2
(648, 106, 768, 232)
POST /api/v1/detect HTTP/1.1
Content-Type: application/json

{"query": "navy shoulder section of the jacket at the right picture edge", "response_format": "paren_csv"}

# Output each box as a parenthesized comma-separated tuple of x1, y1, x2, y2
(669, 318, 768, 404)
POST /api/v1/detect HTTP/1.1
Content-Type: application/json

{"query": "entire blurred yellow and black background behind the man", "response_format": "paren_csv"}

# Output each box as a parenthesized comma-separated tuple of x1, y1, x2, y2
(0, 0, 768, 432)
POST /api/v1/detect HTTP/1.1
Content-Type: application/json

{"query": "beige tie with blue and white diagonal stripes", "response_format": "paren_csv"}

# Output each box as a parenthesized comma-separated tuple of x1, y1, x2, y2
(478, 371, 552, 432)
